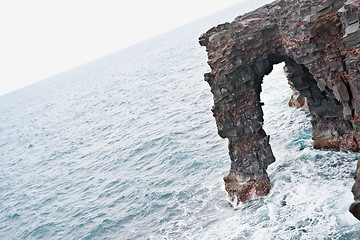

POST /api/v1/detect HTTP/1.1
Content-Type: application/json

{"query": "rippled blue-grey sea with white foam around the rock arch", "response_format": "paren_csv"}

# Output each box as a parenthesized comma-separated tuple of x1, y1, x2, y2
(0, 1, 360, 239)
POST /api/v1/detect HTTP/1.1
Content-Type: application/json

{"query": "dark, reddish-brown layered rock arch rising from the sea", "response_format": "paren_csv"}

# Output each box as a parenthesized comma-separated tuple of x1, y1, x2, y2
(199, 0, 360, 218)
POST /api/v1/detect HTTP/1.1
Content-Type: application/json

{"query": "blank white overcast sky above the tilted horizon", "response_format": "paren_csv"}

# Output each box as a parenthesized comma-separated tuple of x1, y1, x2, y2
(0, 0, 243, 95)
